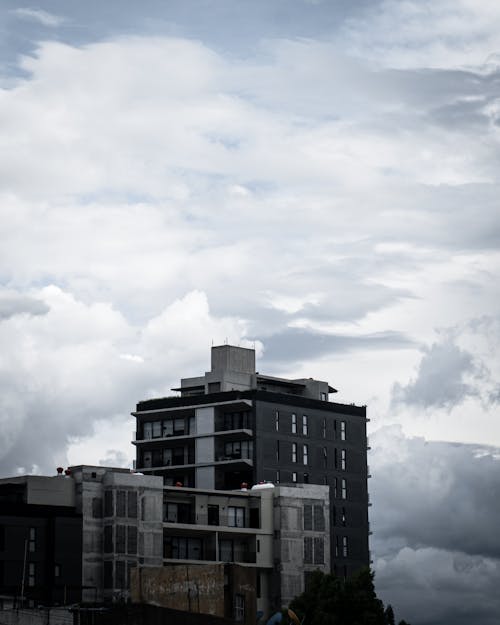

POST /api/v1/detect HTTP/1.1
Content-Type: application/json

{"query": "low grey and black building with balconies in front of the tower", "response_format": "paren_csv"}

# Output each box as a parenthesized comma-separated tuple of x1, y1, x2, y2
(0, 465, 330, 622)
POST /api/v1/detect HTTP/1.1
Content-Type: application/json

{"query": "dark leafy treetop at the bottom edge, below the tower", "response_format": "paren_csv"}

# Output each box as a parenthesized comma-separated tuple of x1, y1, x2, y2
(290, 569, 408, 625)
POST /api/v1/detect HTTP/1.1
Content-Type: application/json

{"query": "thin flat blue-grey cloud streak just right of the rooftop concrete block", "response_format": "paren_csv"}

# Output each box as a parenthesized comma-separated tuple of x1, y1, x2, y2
(256, 328, 413, 364)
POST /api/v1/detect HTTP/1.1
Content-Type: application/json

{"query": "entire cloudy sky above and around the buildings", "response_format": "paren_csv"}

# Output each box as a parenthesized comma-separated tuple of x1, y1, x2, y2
(0, 0, 500, 625)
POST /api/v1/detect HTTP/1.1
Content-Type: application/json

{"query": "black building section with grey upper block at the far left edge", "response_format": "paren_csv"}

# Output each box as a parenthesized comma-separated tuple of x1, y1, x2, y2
(0, 475, 82, 607)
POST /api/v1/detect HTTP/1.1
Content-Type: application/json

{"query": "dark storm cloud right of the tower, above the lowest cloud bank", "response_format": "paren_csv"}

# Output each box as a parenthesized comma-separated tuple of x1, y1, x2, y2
(370, 426, 500, 558)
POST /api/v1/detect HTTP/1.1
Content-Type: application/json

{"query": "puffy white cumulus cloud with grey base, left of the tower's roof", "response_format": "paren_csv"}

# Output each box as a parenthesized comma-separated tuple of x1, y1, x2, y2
(0, 286, 249, 475)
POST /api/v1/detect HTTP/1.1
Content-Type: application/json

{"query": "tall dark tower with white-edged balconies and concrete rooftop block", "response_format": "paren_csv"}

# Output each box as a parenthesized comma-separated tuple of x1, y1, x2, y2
(133, 345, 369, 576)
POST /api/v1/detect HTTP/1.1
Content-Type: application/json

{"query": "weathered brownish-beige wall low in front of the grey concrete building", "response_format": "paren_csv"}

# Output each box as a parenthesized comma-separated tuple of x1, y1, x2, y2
(130, 564, 224, 616)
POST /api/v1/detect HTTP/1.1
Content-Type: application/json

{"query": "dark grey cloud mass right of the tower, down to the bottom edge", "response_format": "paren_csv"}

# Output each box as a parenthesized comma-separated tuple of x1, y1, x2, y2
(370, 426, 500, 625)
